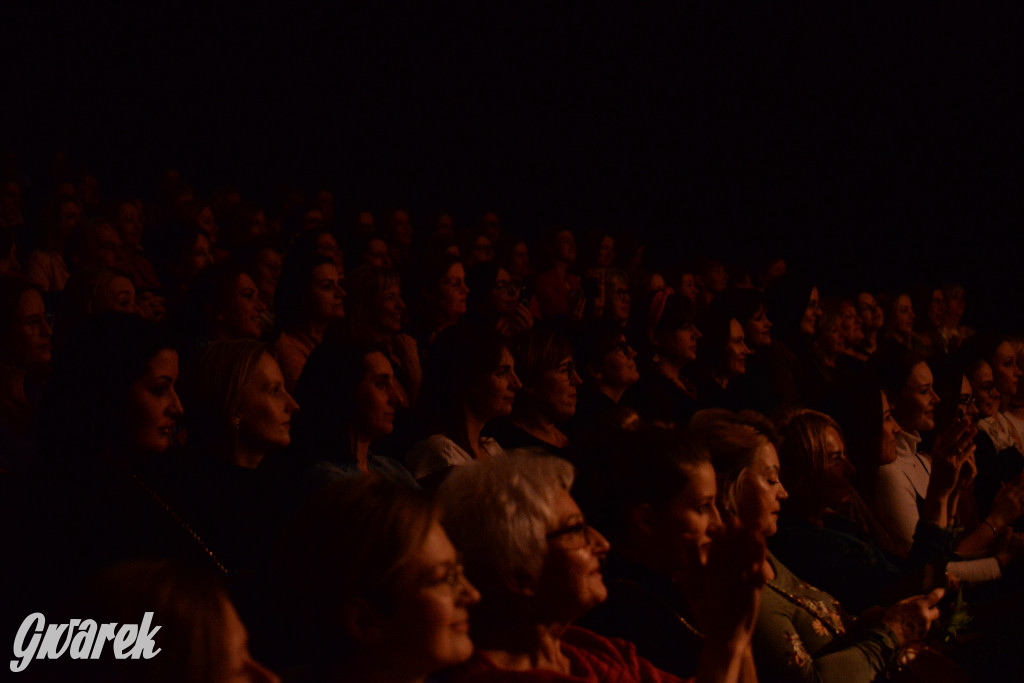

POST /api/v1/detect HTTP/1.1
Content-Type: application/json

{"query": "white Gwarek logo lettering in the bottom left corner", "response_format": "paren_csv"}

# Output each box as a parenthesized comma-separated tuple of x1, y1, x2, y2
(10, 612, 161, 674)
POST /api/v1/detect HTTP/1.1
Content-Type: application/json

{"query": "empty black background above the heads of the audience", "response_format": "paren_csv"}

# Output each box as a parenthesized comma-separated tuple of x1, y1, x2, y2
(0, 2, 1024, 324)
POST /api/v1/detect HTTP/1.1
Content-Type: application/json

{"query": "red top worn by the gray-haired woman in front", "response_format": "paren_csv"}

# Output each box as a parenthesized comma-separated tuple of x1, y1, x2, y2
(442, 626, 692, 683)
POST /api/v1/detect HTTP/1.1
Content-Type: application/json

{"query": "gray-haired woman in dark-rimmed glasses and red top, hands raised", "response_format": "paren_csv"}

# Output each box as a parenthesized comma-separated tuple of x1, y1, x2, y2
(439, 454, 764, 683)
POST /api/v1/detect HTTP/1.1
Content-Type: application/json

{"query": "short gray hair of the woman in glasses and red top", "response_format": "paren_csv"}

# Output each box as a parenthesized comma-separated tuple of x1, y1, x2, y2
(438, 451, 574, 600)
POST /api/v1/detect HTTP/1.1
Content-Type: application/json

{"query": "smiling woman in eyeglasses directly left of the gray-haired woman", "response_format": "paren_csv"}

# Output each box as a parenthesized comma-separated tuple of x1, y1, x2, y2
(267, 473, 480, 683)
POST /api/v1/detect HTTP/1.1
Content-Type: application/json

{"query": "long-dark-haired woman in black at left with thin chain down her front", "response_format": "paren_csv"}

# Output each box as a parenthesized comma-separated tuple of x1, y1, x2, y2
(0, 312, 206, 638)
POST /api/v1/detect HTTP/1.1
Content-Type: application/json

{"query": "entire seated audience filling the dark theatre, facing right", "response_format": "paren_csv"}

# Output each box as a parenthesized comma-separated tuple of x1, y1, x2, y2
(0, 158, 1024, 683)
